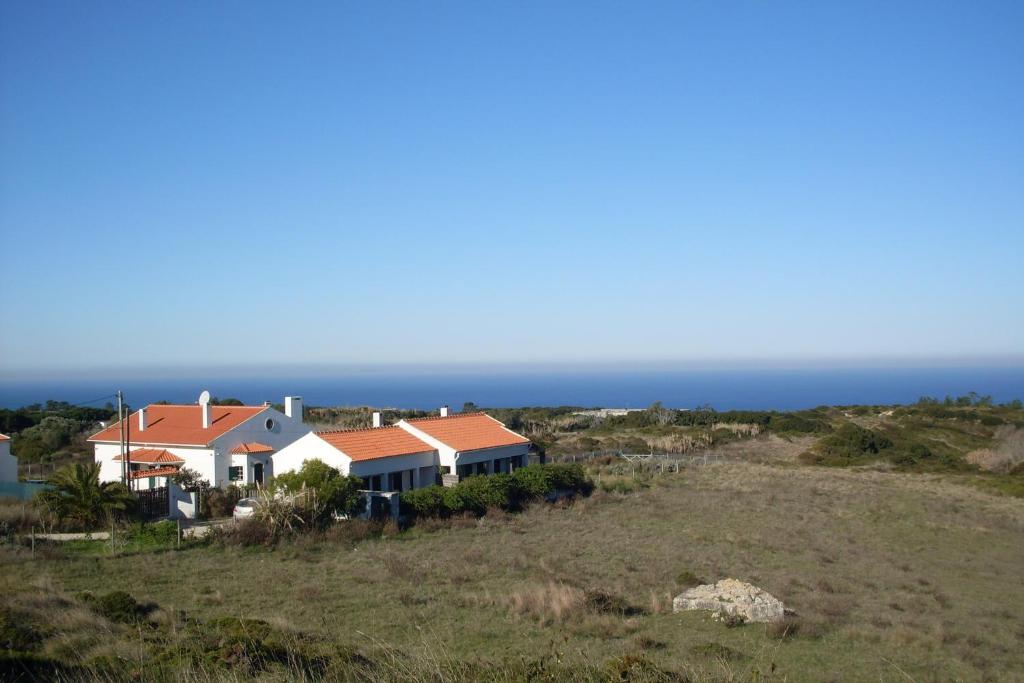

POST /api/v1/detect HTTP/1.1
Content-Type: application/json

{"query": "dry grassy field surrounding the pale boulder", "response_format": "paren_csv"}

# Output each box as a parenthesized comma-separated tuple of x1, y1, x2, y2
(0, 463, 1024, 681)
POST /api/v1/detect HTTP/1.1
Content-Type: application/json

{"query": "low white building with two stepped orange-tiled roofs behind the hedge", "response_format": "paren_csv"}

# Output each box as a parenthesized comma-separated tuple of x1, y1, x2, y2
(273, 409, 529, 492)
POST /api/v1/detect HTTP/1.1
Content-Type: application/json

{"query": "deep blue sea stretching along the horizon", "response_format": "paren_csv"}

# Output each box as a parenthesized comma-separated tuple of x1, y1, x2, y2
(0, 367, 1024, 410)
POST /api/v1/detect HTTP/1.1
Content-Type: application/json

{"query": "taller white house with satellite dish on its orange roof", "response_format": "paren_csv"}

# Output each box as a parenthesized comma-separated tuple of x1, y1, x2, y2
(89, 392, 309, 488)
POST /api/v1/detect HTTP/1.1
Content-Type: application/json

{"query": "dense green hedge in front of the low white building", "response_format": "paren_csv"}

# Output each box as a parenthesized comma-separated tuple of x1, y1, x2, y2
(400, 463, 594, 517)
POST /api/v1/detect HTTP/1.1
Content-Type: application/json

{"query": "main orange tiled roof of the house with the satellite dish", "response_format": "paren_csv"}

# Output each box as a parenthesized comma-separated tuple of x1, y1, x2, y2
(89, 405, 267, 445)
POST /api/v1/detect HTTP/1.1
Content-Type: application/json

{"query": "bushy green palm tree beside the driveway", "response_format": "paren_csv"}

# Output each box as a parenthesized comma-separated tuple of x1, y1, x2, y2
(36, 463, 134, 529)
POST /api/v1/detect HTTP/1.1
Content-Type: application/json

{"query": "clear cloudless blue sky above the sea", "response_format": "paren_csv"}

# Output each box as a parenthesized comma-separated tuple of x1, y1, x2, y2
(0, 0, 1024, 374)
